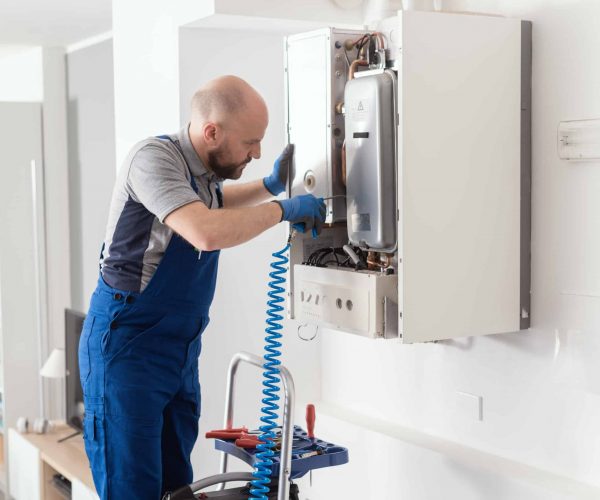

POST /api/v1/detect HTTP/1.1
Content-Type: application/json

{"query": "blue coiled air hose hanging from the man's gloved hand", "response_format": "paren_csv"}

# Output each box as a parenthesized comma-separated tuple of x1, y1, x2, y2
(250, 241, 290, 500)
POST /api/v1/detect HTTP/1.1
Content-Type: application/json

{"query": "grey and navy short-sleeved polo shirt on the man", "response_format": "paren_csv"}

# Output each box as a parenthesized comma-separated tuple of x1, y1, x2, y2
(100, 125, 222, 292)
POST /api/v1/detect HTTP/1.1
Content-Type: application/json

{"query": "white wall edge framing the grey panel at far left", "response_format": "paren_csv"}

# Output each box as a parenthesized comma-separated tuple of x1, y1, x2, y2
(0, 46, 71, 418)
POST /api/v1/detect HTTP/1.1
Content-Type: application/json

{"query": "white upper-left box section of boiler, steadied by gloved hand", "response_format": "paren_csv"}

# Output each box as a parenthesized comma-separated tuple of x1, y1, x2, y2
(285, 28, 364, 223)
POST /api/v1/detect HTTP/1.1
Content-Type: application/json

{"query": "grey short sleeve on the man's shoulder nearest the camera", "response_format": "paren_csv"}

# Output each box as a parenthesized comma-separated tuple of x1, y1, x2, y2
(126, 144, 202, 223)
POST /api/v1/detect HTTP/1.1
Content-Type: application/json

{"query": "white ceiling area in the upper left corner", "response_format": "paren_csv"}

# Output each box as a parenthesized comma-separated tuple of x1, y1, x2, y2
(0, 0, 112, 46)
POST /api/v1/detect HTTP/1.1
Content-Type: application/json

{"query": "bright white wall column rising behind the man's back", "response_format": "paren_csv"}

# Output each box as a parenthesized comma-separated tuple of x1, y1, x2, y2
(113, 0, 213, 164)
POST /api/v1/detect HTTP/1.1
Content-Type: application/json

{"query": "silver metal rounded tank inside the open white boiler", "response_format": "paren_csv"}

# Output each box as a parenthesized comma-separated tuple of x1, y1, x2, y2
(344, 70, 397, 252)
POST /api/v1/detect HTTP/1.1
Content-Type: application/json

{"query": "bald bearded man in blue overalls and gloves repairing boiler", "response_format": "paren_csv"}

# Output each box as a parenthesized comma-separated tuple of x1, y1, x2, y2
(79, 76, 325, 500)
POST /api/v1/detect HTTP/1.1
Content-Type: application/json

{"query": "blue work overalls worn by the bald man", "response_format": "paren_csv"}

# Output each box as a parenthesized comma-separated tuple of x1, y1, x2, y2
(79, 137, 222, 500)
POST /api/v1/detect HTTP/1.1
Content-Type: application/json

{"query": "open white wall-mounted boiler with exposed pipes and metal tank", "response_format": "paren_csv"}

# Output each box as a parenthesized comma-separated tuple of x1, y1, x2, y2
(286, 11, 531, 343)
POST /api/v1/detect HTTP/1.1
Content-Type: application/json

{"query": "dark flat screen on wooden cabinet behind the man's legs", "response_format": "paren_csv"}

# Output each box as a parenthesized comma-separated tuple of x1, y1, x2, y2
(65, 309, 85, 431)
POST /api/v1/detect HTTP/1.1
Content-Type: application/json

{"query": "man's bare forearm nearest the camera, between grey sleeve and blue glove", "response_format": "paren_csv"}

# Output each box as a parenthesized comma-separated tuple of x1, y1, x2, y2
(165, 202, 282, 250)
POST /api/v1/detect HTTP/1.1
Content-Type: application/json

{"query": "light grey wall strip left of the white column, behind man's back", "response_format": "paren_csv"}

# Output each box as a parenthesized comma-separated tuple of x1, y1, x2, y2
(67, 40, 115, 311)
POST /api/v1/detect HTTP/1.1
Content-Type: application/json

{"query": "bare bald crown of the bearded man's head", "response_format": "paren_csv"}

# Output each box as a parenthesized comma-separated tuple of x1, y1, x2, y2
(191, 75, 267, 126)
